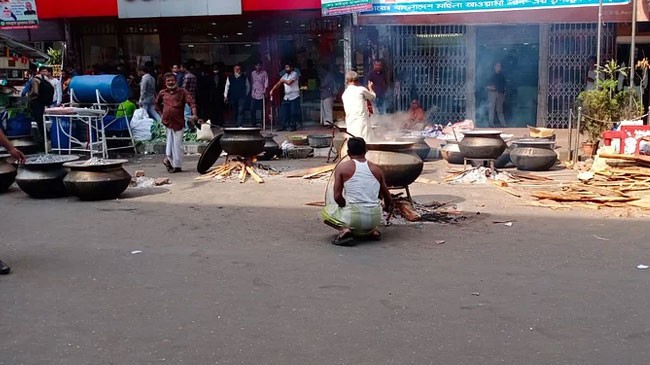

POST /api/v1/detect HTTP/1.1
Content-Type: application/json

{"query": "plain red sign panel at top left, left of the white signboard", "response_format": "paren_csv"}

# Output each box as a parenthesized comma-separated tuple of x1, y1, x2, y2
(37, 0, 117, 19)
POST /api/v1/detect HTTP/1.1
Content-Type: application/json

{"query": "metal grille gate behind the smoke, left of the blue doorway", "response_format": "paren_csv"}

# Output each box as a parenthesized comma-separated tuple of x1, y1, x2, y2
(388, 25, 468, 124)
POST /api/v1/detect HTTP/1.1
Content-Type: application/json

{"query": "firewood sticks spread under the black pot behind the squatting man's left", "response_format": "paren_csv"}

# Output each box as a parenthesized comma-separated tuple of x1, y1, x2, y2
(195, 157, 279, 184)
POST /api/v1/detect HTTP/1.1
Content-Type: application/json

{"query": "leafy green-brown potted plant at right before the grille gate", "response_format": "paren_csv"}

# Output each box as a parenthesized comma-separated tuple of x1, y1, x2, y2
(577, 60, 643, 156)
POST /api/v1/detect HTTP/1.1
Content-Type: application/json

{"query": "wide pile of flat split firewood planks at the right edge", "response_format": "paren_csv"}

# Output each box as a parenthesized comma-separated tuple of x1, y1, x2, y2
(532, 154, 650, 209)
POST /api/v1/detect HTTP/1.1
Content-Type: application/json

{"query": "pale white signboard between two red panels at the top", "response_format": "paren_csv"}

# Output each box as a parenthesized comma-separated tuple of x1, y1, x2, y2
(117, 0, 242, 19)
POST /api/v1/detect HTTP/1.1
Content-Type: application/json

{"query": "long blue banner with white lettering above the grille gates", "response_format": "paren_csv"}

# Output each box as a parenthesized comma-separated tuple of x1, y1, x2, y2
(364, 0, 630, 15)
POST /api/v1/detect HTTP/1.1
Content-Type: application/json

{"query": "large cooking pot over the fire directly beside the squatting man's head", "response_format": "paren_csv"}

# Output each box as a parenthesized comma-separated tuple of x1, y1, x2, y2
(366, 142, 424, 187)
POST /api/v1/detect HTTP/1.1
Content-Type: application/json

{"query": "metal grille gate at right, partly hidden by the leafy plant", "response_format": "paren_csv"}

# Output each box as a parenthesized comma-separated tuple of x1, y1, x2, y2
(546, 24, 615, 128)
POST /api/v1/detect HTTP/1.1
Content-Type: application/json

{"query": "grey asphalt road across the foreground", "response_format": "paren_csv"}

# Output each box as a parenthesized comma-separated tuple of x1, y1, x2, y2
(0, 155, 650, 365)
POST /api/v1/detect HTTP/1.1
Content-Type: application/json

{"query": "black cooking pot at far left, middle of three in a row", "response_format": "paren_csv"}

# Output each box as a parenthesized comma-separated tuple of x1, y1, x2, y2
(16, 155, 79, 199)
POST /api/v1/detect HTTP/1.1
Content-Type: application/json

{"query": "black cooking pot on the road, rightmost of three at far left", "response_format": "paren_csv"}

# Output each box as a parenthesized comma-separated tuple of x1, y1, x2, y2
(63, 158, 131, 200)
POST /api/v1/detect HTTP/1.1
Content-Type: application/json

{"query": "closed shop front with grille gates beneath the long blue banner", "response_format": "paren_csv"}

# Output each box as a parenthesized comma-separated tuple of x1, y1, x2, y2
(355, 0, 647, 128)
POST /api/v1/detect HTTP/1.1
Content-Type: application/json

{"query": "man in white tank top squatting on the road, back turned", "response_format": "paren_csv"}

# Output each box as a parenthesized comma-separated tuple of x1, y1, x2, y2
(321, 137, 393, 245)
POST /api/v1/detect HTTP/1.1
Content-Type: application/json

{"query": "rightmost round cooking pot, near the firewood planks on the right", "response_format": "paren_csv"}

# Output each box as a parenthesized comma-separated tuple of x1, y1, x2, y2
(510, 139, 557, 171)
